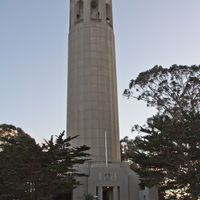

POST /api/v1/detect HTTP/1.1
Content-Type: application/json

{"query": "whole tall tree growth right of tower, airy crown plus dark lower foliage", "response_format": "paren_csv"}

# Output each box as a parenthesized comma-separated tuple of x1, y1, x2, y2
(124, 65, 200, 200)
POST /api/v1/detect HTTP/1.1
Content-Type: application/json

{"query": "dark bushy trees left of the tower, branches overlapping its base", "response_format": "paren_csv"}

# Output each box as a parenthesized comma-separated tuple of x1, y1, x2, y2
(0, 124, 89, 200)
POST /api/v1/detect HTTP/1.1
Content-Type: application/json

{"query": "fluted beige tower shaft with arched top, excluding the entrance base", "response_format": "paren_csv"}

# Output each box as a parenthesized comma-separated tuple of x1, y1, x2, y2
(67, 0, 121, 162)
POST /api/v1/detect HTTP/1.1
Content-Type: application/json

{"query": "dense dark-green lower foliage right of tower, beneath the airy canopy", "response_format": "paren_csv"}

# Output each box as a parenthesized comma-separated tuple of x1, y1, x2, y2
(123, 114, 200, 199)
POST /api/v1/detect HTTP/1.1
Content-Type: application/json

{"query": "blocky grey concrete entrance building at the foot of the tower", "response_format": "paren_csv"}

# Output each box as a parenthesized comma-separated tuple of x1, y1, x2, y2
(73, 162, 158, 200)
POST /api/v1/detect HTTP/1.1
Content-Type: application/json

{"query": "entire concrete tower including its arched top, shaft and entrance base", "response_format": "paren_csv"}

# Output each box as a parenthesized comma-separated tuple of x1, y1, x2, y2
(67, 0, 156, 200)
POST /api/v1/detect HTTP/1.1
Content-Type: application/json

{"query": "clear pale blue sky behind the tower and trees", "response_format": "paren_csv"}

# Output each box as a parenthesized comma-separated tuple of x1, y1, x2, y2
(0, 0, 200, 141)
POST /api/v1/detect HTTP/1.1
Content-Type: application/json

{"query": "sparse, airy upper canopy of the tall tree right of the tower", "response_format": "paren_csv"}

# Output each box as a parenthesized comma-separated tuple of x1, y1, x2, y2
(124, 65, 200, 118)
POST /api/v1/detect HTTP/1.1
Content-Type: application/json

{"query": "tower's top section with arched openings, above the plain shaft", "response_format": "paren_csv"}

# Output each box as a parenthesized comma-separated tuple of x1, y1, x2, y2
(70, 0, 113, 29)
